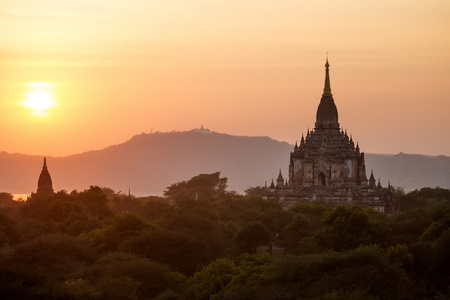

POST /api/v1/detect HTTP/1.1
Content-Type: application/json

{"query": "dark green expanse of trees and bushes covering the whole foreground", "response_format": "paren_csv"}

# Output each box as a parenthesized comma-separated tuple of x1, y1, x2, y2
(0, 173, 450, 300)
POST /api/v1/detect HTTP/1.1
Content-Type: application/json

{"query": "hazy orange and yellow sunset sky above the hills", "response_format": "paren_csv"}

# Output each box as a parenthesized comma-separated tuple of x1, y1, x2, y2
(0, 0, 450, 156)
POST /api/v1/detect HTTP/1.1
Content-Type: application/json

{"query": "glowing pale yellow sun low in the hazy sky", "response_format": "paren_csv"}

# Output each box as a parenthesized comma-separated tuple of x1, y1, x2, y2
(19, 82, 59, 117)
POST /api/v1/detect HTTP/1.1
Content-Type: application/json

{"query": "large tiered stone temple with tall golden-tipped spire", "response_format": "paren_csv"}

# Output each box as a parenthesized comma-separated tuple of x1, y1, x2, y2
(263, 59, 396, 213)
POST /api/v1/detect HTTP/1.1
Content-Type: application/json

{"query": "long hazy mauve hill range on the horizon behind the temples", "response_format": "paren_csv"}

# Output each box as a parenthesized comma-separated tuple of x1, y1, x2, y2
(0, 129, 450, 196)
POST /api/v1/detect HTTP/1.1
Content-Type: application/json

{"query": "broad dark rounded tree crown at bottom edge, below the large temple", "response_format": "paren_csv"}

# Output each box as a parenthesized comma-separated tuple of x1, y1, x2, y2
(268, 246, 415, 300)
